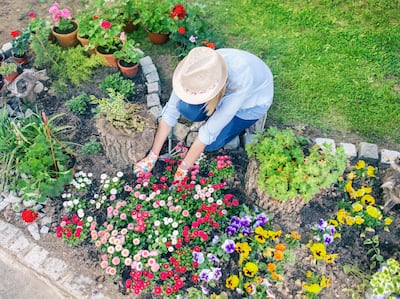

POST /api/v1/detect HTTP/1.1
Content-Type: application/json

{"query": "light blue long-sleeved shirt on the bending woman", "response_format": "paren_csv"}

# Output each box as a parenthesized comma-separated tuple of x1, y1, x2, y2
(161, 49, 274, 145)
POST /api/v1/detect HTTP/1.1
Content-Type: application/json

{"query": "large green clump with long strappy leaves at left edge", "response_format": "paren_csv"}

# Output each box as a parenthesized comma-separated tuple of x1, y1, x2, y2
(0, 112, 73, 202)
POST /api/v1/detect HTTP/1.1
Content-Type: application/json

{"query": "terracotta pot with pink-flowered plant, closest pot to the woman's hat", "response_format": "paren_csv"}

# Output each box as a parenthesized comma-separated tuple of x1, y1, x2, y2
(114, 32, 144, 78)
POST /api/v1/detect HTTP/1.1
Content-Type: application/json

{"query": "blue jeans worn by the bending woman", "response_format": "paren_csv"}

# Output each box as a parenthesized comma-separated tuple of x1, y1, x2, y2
(178, 101, 258, 152)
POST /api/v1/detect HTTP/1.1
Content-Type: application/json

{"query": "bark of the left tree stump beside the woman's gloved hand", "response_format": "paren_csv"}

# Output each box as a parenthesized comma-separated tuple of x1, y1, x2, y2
(96, 111, 156, 169)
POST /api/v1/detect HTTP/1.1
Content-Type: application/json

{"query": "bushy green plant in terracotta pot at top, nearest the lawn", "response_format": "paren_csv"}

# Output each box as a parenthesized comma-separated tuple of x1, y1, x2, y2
(140, 0, 174, 44)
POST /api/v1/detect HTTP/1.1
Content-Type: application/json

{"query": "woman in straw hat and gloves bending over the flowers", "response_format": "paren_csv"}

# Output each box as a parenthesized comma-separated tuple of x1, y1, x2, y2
(133, 47, 274, 181)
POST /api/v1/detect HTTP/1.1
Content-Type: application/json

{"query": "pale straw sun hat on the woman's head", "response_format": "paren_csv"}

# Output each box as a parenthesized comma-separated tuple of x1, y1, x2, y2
(172, 47, 228, 104)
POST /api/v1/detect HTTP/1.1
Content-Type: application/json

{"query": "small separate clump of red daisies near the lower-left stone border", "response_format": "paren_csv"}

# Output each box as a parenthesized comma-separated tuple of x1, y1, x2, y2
(56, 215, 87, 246)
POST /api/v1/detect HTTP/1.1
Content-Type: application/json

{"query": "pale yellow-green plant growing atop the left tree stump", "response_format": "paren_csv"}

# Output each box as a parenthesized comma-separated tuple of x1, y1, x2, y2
(90, 88, 146, 133)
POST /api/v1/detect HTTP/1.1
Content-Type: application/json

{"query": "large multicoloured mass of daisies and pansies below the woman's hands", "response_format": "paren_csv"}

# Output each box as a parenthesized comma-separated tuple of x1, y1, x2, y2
(57, 144, 300, 298)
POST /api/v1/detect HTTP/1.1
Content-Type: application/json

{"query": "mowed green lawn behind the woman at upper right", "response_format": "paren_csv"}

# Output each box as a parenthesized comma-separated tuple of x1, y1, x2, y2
(205, 0, 400, 143)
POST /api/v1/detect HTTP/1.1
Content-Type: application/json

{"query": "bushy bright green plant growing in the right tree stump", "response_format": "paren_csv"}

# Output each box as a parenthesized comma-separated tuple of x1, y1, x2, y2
(246, 127, 346, 200)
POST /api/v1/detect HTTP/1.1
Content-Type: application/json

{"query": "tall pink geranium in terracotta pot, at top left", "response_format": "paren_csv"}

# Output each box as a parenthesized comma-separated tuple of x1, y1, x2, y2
(49, 1, 78, 48)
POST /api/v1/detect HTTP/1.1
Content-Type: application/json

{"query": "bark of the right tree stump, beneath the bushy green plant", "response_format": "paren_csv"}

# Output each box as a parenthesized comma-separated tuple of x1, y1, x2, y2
(245, 158, 307, 220)
